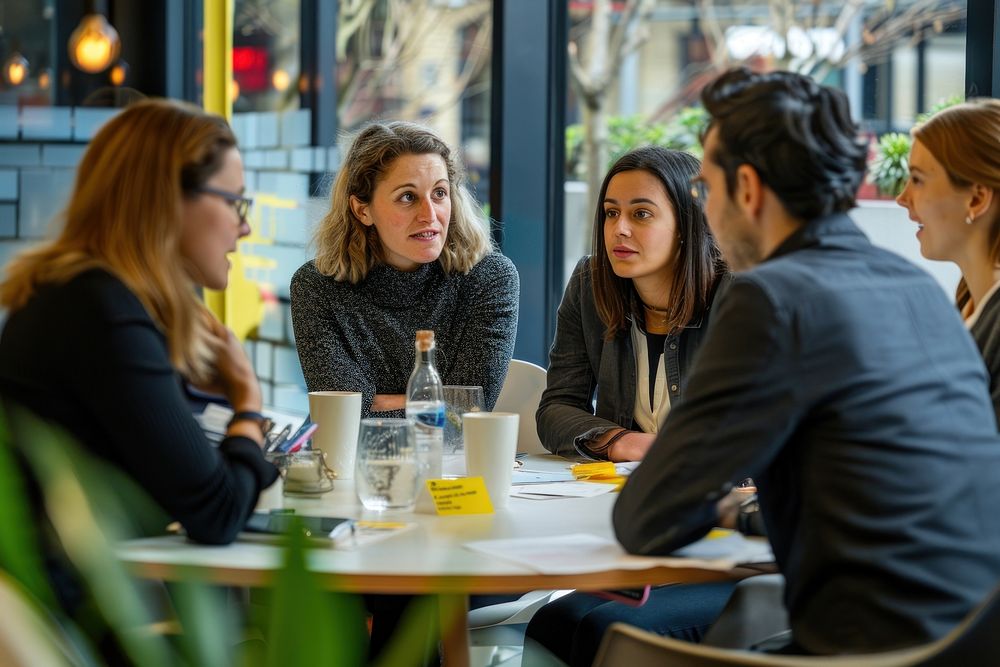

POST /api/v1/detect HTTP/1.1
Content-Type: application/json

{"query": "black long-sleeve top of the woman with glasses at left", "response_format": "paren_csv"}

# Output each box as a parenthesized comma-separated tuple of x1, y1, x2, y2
(0, 270, 277, 544)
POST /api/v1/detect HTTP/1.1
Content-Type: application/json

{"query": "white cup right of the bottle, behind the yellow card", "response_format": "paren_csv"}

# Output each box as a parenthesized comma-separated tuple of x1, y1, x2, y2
(462, 412, 521, 509)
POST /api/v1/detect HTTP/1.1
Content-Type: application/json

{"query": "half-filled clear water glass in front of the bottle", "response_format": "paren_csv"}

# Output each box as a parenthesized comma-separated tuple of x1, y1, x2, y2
(354, 419, 420, 510)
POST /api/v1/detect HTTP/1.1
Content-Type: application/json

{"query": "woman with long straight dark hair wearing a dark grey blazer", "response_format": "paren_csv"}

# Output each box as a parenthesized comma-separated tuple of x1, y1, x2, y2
(537, 147, 725, 461)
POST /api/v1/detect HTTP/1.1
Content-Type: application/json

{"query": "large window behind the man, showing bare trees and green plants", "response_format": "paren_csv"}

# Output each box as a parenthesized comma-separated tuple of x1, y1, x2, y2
(564, 0, 966, 292)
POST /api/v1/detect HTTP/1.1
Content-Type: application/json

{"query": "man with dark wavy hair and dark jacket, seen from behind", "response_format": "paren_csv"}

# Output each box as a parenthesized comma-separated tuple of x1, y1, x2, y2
(614, 69, 1000, 654)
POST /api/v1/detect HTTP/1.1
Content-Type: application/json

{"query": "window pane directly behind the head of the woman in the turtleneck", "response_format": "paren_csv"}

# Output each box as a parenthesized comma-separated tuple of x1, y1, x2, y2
(337, 0, 493, 203)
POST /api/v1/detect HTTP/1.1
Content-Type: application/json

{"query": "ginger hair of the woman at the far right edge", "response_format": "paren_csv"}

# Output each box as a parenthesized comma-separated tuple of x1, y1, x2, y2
(913, 98, 1000, 308)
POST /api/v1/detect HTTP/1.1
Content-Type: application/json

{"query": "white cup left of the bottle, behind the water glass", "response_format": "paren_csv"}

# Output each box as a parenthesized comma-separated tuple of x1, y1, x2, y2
(309, 391, 361, 479)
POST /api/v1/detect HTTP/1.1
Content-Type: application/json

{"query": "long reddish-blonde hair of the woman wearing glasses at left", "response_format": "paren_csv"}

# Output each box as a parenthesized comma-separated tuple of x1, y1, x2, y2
(0, 100, 236, 382)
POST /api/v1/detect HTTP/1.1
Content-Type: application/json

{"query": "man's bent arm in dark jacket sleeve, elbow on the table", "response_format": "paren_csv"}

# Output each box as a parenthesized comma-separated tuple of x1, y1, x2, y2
(614, 278, 800, 554)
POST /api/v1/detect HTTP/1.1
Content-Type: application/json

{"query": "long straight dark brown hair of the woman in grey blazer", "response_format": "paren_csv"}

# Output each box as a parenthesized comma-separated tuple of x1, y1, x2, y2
(590, 146, 726, 340)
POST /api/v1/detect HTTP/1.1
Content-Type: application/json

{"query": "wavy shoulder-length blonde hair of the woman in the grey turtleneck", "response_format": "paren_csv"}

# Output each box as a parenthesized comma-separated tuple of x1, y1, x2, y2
(313, 121, 493, 284)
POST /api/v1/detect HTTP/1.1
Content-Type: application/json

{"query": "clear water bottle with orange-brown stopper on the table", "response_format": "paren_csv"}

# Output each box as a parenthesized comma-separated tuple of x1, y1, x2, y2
(406, 331, 444, 480)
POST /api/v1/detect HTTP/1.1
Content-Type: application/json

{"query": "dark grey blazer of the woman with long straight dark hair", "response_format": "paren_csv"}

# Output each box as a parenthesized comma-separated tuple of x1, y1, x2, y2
(535, 257, 724, 456)
